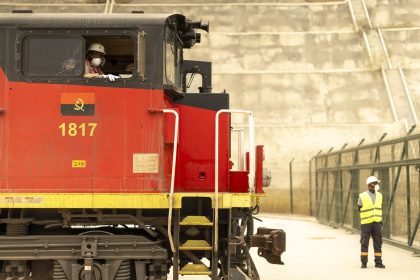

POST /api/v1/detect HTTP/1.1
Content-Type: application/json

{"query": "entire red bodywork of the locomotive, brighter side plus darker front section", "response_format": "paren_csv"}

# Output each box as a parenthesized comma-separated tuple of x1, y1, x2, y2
(0, 68, 230, 193)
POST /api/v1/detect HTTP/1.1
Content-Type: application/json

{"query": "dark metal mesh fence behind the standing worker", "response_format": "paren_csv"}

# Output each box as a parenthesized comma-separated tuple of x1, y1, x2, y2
(309, 129, 420, 250)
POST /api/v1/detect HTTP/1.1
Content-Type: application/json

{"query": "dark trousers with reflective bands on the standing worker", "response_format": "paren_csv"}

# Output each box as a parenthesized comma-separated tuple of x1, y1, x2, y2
(360, 222, 382, 264)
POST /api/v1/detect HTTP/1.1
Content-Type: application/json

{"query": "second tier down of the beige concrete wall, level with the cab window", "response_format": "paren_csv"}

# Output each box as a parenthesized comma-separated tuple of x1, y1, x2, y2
(188, 31, 369, 73)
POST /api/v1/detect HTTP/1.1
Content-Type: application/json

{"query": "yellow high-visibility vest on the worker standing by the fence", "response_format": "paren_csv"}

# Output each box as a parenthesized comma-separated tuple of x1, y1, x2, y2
(359, 192, 382, 225)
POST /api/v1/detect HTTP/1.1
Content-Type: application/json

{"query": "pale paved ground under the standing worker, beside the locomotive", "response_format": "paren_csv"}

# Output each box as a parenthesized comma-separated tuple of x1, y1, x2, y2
(253, 215, 420, 280)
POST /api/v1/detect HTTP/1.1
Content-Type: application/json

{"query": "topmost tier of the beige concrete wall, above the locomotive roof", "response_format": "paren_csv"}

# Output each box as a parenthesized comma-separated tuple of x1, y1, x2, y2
(114, 0, 351, 32)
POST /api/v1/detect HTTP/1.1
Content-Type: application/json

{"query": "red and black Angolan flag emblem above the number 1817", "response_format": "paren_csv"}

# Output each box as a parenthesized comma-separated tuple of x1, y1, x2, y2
(60, 93, 95, 116)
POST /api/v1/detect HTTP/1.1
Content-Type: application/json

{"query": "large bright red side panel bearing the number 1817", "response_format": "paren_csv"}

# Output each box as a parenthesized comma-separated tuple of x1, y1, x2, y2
(0, 69, 168, 193)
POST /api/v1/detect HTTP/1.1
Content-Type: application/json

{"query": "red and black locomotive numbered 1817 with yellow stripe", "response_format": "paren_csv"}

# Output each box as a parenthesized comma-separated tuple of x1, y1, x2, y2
(0, 13, 285, 280)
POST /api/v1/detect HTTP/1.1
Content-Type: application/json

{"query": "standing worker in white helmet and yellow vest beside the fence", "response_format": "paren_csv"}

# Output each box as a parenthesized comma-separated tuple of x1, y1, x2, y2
(357, 176, 385, 268)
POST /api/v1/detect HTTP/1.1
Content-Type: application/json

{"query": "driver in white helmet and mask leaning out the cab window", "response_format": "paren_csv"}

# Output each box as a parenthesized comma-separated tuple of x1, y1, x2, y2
(83, 43, 120, 82)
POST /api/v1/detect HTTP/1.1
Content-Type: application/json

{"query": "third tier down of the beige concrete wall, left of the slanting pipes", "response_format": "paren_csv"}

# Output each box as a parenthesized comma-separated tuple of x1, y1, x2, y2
(213, 72, 392, 122)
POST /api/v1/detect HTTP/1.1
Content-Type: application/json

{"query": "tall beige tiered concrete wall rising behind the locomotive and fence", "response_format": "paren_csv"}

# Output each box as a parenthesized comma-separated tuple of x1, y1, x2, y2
(0, 0, 420, 208)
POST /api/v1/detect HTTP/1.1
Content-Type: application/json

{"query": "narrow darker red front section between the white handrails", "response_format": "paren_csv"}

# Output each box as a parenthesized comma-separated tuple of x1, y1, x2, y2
(167, 98, 230, 192)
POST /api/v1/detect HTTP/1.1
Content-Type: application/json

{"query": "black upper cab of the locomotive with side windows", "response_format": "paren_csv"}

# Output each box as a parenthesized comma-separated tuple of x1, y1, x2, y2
(11, 15, 201, 89)
